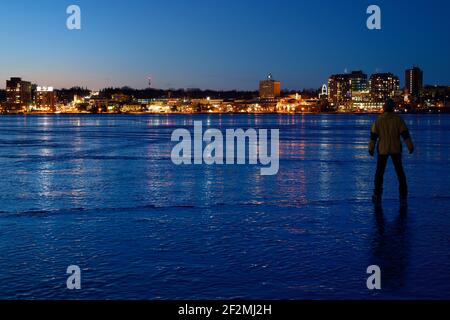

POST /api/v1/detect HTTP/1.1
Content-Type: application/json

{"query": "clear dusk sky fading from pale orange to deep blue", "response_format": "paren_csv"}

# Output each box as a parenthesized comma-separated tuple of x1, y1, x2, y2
(0, 0, 450, 90)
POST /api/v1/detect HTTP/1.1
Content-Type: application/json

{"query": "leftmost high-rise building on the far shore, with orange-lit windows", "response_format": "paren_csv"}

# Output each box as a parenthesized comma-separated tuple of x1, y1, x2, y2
(6, 78, 32, 113)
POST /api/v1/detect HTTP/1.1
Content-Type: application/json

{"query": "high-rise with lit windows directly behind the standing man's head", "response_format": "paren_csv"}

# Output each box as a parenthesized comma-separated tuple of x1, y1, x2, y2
(369, 73, 400, 102)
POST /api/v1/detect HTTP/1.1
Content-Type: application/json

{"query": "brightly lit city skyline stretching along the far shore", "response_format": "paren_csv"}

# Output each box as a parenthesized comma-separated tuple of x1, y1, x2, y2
(0, 63, 450, 114)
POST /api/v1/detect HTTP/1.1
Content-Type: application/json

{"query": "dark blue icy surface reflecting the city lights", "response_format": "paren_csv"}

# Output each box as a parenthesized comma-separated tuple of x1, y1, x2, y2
(0, 115, 450, 299)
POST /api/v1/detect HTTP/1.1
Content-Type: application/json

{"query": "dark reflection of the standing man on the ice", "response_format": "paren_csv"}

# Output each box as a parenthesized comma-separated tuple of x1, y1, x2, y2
(370, 206, 410, 291)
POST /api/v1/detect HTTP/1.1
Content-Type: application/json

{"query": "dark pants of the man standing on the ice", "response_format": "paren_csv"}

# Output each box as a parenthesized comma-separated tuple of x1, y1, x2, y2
(375, 153, 408, 199)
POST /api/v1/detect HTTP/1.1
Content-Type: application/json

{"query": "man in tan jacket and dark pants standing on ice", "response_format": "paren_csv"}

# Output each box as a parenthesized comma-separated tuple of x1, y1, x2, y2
(369, 99, 414, 204)
